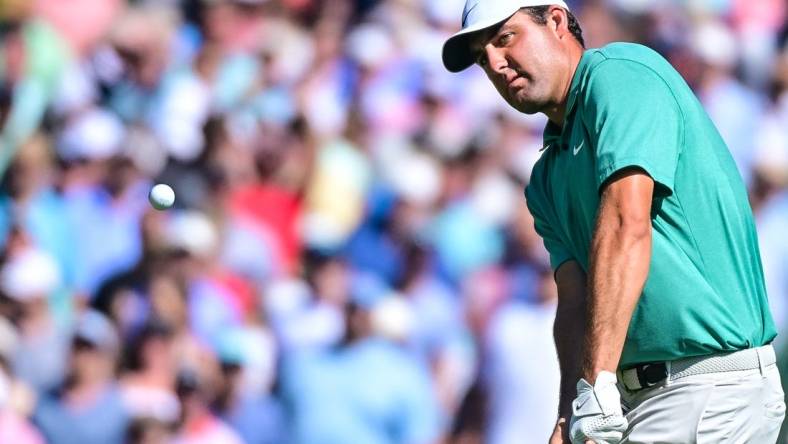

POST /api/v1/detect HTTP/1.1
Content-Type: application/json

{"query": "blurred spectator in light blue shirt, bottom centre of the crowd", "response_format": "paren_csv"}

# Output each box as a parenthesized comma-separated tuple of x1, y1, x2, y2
(283, 284, 442, 444)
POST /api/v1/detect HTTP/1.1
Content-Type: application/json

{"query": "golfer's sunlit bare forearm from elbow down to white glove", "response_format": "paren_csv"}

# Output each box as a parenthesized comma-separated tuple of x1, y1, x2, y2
(582, 219, 651, 384)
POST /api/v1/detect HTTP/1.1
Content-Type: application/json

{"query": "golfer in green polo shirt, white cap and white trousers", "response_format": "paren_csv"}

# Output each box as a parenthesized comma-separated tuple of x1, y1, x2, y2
(443, 0, 785, 443)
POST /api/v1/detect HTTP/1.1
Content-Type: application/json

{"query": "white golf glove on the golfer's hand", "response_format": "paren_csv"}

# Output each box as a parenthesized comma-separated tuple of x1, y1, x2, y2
(569, 371, 628, 444)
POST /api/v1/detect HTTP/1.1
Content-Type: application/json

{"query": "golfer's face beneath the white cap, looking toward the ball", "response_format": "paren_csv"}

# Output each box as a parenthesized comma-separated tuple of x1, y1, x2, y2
(471, 11, 564, 114)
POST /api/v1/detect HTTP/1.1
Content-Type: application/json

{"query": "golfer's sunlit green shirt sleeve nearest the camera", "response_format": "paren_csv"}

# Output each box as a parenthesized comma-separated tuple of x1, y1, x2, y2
(583, 59, 683, 197)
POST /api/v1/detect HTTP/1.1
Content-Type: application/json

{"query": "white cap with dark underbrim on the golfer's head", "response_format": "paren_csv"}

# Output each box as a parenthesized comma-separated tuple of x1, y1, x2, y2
(443, 0, 569, 72)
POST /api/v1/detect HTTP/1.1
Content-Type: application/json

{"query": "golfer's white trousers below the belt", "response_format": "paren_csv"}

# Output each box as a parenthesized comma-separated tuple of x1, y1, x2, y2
(619, 345, 785, 444)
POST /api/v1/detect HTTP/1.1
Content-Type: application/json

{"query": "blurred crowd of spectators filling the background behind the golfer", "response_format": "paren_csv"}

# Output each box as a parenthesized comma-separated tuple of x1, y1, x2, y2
(0, 0, 788, 444)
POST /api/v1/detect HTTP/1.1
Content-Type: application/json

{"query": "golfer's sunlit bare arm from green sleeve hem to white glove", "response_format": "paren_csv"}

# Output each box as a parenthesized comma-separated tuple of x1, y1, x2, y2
(581, 169, 654, 385)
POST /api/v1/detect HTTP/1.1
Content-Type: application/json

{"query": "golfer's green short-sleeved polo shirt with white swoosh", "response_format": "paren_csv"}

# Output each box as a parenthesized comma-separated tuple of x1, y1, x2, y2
(525, 43, 776, 368)
